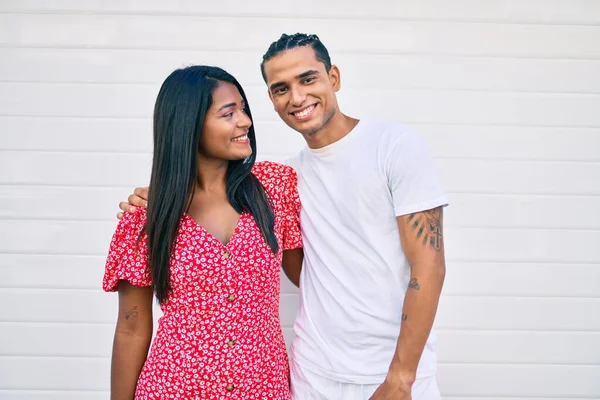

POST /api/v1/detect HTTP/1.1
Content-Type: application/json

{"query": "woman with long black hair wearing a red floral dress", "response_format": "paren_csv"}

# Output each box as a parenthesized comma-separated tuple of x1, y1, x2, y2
(103, 66, 302, 400)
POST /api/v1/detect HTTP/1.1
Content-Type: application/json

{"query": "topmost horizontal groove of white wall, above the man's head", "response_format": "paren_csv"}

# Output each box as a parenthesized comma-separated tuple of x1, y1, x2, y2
(0, 9, 600, 27)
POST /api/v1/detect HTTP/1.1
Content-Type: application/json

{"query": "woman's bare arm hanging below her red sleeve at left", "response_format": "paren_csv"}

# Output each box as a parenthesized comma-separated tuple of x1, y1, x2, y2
(110, 280, 153, 400)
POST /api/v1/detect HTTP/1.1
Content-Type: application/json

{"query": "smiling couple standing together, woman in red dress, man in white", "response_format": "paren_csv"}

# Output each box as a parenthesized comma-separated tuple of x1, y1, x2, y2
(103, 34, 447, 400)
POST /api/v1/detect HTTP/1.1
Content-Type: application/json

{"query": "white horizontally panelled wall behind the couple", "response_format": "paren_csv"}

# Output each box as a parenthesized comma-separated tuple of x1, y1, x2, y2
(0, 0, 600, 400)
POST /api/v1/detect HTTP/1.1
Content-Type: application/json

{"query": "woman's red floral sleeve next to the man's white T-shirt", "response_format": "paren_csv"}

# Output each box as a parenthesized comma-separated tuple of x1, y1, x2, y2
(282, 166, 302, 250)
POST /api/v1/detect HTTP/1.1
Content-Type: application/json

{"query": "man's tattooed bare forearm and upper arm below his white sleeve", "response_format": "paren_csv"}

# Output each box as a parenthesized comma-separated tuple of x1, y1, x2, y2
(371, 207, 446, 400)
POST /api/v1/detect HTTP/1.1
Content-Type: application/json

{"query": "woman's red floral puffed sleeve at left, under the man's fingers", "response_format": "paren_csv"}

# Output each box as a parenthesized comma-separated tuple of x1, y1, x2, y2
(102, 209, 152, 292)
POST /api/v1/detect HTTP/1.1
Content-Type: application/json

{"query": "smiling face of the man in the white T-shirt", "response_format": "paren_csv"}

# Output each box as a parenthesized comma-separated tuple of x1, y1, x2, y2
(265, 46, 340, 140)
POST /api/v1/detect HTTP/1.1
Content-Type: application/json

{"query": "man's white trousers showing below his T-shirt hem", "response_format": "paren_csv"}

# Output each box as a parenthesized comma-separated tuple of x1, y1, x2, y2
(290, 362, 441, 400)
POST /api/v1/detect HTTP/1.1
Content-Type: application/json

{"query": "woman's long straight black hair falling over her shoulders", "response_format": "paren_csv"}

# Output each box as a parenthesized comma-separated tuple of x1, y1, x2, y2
(144, 66, 279, 303)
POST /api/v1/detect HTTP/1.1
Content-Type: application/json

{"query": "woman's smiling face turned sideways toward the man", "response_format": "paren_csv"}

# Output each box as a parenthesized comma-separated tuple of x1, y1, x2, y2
(199, 82, 252, 160)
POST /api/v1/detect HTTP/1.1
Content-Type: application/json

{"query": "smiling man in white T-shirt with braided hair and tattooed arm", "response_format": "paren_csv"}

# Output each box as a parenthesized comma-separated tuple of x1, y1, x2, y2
(120, 34, 447, 400)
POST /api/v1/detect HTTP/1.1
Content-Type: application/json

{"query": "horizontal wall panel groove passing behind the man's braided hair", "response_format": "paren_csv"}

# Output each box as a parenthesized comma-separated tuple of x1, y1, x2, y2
(0, 43, 600, 61)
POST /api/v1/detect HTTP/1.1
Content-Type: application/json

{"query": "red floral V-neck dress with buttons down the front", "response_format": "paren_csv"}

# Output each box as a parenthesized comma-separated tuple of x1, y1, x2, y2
(103, 162, 302, 400)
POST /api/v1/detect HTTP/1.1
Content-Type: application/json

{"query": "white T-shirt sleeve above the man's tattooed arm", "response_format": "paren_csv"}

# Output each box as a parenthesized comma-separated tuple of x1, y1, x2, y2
(385, 130, 448, 216)
